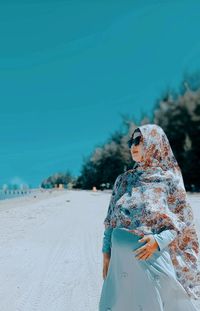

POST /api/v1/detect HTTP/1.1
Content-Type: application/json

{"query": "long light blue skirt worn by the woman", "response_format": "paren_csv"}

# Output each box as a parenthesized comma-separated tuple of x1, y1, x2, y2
(99, 228, 198, 311)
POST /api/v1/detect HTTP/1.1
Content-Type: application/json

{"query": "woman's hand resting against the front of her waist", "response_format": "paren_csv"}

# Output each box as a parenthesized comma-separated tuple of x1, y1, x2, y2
(133, 234, 159, 260)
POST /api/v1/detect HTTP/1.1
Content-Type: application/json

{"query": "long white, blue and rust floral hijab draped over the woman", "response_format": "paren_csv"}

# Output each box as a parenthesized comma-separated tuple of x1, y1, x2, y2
(104, 124, 200, 299)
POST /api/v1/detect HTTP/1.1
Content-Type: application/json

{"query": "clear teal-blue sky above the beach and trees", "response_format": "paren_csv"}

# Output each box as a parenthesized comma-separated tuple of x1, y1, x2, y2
(0, 0, 200, 186)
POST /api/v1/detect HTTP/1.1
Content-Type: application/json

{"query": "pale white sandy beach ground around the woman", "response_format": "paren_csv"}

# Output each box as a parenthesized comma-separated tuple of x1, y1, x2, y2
(0, 190, 200, 311)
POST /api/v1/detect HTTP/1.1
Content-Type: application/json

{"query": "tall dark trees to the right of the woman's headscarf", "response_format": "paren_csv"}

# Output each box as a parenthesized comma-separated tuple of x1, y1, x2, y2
(153, 75, 200, 191)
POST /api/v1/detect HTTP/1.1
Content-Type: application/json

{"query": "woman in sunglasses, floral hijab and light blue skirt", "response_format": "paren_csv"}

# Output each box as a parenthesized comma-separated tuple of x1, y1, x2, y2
(99, 124, 200, 311)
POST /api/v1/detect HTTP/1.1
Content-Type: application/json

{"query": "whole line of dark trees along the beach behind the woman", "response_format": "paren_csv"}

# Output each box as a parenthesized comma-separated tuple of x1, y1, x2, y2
(41, 73, 200, 191)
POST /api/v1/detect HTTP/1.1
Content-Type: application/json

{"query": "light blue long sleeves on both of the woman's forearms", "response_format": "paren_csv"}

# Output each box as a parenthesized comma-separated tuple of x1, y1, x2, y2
(102, 228, 177, 254)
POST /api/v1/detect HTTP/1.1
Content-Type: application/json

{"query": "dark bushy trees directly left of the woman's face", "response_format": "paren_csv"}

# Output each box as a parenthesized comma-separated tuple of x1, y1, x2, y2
(75, 116, 149, 189)
